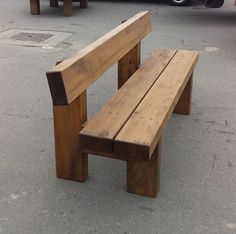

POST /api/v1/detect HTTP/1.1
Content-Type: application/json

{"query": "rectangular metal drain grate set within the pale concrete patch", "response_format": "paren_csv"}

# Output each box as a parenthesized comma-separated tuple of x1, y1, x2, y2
(10, 32, 53, 42)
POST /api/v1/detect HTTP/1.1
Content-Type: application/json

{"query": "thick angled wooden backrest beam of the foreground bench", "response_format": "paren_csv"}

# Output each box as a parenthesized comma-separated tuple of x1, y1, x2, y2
(47, 11, 151, 105)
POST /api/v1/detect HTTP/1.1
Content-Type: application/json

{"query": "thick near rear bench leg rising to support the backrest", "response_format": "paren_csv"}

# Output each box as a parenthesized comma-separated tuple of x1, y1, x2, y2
(53, 91, 88, 182)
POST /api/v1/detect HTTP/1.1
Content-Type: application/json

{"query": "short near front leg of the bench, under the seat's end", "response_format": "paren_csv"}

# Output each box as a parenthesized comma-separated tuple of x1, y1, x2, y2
(127, 141, 161, 197)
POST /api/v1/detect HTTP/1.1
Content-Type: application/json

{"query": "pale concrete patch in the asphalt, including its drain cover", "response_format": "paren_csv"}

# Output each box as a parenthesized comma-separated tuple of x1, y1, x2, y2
(0, 29, 72, 48)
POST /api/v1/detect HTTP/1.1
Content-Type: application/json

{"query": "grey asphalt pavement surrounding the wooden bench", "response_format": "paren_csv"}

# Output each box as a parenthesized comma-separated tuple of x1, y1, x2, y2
(0, 0, 236, 234)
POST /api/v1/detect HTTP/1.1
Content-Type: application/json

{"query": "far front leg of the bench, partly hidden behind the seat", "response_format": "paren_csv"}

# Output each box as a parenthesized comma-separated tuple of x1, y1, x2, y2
(174, 75, 193, 115)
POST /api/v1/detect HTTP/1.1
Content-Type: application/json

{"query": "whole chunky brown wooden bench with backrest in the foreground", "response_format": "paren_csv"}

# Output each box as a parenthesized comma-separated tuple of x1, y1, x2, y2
(47, 11, 198, 197)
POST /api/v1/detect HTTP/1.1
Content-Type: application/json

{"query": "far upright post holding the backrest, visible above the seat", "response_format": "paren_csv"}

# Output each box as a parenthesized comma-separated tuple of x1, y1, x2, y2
(118, 42, 141, 89)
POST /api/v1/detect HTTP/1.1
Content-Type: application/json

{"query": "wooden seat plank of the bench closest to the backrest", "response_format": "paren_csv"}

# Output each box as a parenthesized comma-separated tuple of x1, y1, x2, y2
(80, 50, 176, 153)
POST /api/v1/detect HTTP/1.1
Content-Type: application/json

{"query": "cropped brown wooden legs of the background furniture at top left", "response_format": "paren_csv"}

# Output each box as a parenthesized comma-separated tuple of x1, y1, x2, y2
(30, 0, 88, 16)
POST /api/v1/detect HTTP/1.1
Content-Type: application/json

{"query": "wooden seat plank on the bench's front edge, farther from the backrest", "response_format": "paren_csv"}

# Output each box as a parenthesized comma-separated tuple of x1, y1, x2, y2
(114, 50, 198, 160)
